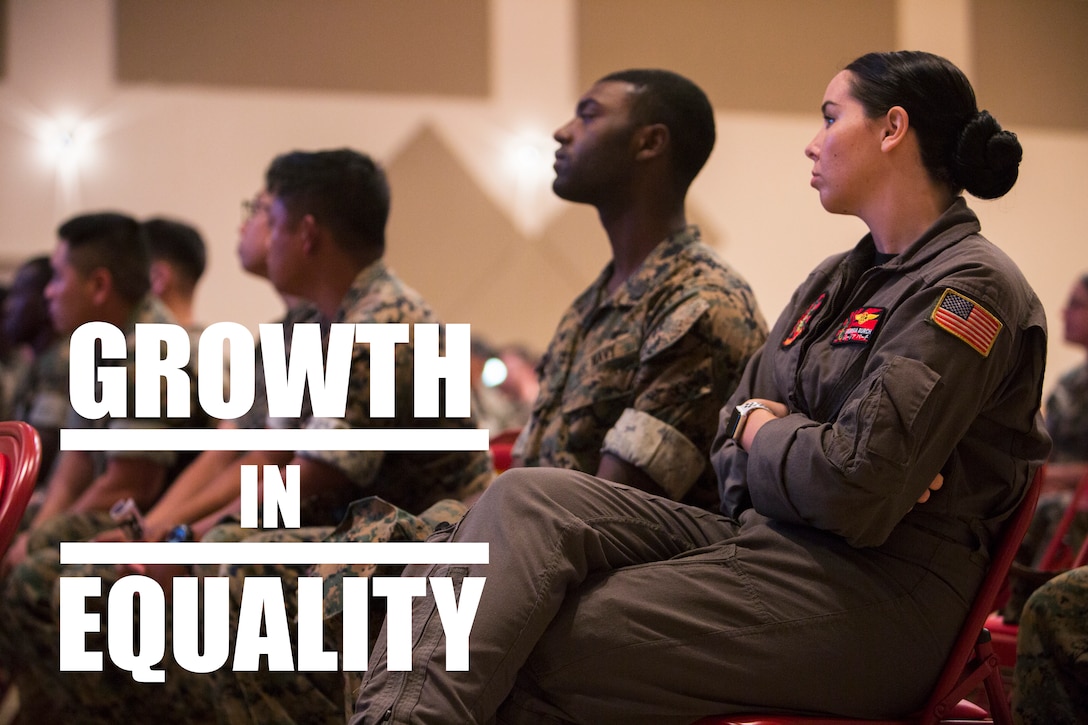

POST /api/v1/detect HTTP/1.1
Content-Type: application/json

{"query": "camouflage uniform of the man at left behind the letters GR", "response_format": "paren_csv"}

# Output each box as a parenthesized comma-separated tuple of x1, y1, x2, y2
(0, 295, 206, 722)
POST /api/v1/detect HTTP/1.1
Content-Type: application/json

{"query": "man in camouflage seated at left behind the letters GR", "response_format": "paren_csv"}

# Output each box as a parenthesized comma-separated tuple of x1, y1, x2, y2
(0, 213, 204, 712)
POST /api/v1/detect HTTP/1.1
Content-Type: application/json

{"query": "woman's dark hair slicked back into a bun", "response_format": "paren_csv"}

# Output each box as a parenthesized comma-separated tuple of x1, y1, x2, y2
(846, 50, 1024, 199)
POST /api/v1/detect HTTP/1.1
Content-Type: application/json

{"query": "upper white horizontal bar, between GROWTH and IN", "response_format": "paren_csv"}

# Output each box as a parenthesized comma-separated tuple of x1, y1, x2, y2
(61, 428, 490, 451)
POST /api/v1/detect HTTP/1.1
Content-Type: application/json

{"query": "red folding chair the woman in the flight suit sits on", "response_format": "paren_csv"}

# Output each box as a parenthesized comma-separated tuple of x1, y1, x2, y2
(695, 468, 1042, 725)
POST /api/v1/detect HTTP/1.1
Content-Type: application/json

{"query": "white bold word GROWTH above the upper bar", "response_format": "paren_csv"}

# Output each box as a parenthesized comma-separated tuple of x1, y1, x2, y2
(69, 322, 471, 420)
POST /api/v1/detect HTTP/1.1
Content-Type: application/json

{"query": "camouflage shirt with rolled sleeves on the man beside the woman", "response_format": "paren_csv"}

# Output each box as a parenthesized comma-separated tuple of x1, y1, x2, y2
(514, 226, 767, 508)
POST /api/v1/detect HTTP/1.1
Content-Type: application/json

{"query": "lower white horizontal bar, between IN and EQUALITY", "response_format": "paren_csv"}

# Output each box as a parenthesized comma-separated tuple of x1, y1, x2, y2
(61, 541, 489, 565)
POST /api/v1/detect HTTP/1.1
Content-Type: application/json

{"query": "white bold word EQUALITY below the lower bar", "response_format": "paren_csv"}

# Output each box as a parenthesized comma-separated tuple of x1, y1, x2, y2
(60, 575, 484, 683)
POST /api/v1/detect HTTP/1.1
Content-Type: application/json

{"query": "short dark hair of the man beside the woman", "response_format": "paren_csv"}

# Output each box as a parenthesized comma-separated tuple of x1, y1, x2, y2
(598, 69, 716, 188)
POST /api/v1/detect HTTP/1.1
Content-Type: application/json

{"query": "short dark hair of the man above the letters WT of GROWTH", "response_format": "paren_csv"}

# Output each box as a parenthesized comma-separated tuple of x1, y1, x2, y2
(264, 148, 390, 254)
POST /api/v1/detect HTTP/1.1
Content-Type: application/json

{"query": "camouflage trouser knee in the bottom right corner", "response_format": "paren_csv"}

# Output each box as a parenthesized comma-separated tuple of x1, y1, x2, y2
(1012, 567, 1088, 725)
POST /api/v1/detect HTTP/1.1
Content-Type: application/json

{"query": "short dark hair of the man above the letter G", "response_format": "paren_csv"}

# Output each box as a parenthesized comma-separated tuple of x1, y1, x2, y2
(57, 211, 151, 305)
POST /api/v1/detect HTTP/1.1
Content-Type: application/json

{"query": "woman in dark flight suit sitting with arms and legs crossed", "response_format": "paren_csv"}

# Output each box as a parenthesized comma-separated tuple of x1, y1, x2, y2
(351, 51, 1050, 725)
